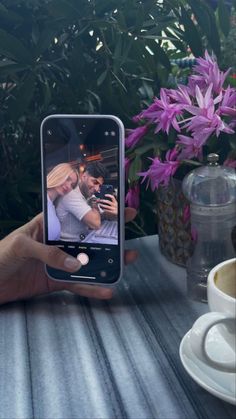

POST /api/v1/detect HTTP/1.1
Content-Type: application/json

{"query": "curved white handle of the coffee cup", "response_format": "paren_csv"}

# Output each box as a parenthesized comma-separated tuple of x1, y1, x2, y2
(190, 312, 236, 372)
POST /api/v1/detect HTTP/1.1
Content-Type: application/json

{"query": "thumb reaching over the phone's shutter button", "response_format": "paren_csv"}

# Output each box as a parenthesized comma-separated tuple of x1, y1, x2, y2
(21, 237, 81, 272)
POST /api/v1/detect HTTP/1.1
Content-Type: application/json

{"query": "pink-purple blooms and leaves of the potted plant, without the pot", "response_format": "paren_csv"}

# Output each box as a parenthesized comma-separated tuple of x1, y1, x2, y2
(125, 51, 236, 208)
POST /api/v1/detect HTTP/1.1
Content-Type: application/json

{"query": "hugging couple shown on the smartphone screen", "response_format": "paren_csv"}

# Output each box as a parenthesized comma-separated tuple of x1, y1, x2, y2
(47, 162, 118, 242)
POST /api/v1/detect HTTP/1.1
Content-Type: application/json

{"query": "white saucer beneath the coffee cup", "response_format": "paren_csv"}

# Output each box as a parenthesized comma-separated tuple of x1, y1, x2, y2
(179, 330, 236, 405)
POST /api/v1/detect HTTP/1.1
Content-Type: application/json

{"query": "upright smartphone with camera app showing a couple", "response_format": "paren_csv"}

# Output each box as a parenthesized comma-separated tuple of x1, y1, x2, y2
(40, 115, 124, 285)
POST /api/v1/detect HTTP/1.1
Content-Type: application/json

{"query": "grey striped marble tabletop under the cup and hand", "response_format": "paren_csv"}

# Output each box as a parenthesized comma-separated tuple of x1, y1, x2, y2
(0, 236, 235, 419)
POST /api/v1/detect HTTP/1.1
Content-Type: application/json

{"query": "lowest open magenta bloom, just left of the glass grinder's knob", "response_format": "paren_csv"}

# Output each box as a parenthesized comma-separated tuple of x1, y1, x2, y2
(138, 150, 180, 191)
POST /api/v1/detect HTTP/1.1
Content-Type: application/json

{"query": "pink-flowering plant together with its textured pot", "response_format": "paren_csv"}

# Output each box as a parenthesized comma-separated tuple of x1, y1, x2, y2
(125, 51, 236, 265)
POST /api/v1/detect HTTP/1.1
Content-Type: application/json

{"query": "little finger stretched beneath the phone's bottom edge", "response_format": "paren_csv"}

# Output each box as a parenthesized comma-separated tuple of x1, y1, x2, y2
(64, 284, 113, 300)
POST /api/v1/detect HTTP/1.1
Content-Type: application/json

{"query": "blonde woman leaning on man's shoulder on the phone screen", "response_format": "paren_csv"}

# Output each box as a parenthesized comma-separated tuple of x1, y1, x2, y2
(47, 163, 78, 240)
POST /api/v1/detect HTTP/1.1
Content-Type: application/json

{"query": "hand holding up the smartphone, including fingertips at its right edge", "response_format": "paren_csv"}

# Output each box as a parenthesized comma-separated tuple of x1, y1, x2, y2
(0, 208, 137, 304)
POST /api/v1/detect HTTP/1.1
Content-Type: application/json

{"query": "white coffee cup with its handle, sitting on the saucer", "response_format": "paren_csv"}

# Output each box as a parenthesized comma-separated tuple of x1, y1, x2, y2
(190, 258, 236, 373)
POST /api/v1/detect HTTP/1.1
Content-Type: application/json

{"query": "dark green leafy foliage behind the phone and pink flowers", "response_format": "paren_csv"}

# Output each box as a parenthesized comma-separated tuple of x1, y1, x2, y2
(0, 0, 233, 240)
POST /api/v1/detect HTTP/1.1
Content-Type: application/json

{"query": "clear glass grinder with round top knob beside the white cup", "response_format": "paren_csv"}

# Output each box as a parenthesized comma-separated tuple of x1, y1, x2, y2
(182, 153, 236, 302)
